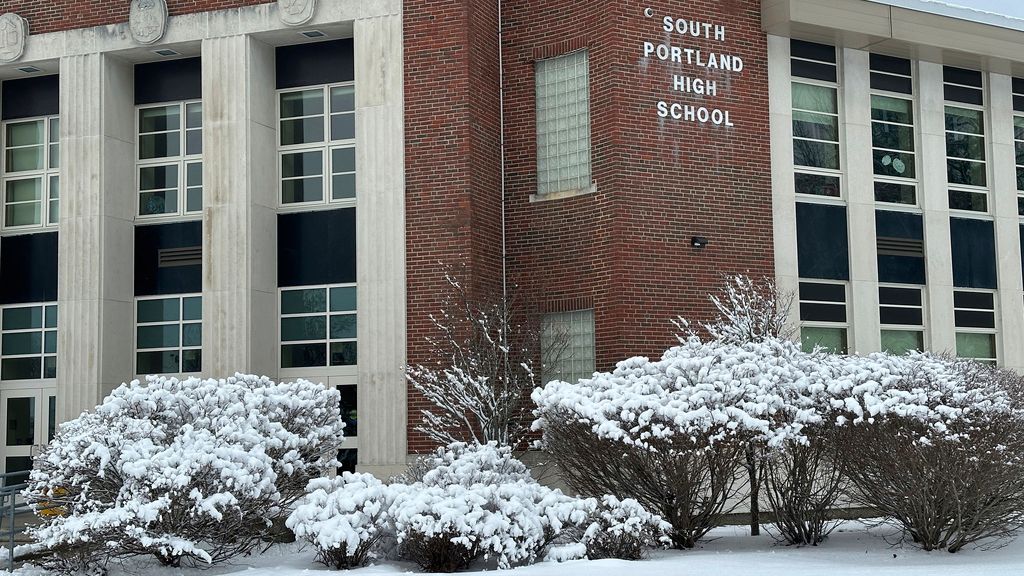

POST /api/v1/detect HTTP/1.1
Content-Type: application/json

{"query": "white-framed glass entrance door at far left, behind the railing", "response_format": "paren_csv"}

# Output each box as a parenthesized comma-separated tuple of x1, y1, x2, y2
(0, 388, 56, 484)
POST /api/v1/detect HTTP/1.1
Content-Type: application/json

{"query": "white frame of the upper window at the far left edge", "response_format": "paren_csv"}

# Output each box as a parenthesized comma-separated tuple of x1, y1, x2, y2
(0, 114, 61, 234)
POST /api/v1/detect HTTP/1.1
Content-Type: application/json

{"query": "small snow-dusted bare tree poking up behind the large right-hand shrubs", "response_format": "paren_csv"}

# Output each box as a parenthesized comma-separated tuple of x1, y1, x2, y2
(675, 275, 796, 536)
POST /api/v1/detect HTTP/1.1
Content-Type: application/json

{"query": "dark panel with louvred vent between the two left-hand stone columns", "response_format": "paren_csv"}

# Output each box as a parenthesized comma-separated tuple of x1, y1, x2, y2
(135, 221, 203, 295)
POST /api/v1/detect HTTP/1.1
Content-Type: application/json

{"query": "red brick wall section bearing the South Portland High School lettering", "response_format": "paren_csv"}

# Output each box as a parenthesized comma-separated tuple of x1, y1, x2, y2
(504, 0, 773, 370)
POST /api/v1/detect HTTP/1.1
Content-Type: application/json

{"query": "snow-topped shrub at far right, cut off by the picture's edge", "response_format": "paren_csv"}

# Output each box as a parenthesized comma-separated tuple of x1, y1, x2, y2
(830, 355, 1024, 551)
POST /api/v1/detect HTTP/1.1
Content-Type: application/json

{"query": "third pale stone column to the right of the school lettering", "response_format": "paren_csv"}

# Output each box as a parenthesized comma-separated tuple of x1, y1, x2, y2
(918, 60, 956, 354)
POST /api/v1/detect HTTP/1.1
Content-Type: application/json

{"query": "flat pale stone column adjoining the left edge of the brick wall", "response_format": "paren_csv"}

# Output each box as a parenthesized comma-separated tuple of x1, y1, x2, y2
(353, 14, 408, 476)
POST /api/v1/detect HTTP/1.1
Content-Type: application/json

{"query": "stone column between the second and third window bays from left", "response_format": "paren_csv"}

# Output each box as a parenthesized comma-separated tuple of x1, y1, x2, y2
(203, 35, 278, 377)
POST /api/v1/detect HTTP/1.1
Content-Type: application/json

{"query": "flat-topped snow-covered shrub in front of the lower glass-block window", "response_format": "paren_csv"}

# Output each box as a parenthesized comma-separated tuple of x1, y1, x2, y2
(532, 336, 825, 547)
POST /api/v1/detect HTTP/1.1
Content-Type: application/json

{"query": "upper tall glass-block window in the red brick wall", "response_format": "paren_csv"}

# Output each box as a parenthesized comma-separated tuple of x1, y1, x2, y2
(535, 50, 592, 196)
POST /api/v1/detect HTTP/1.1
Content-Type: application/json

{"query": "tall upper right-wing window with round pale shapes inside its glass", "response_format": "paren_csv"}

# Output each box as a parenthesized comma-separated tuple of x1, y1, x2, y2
(870, 54, 918, 204)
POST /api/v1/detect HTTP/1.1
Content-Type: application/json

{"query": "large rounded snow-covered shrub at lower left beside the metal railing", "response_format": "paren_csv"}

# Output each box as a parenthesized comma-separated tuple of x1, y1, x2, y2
(26, 374, 344, 571)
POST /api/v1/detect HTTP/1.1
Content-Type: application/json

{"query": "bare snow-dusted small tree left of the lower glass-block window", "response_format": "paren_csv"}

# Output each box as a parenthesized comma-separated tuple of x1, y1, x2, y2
(406, 271, 565, 449)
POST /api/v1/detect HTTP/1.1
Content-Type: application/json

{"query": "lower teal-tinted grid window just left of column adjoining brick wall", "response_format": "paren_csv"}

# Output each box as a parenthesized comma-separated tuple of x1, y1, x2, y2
(281, 284, 356, 368)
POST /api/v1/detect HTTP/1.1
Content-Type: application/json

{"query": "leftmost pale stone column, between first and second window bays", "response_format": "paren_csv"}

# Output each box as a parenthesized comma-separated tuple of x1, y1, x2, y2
(57, 53, 135, 421)
